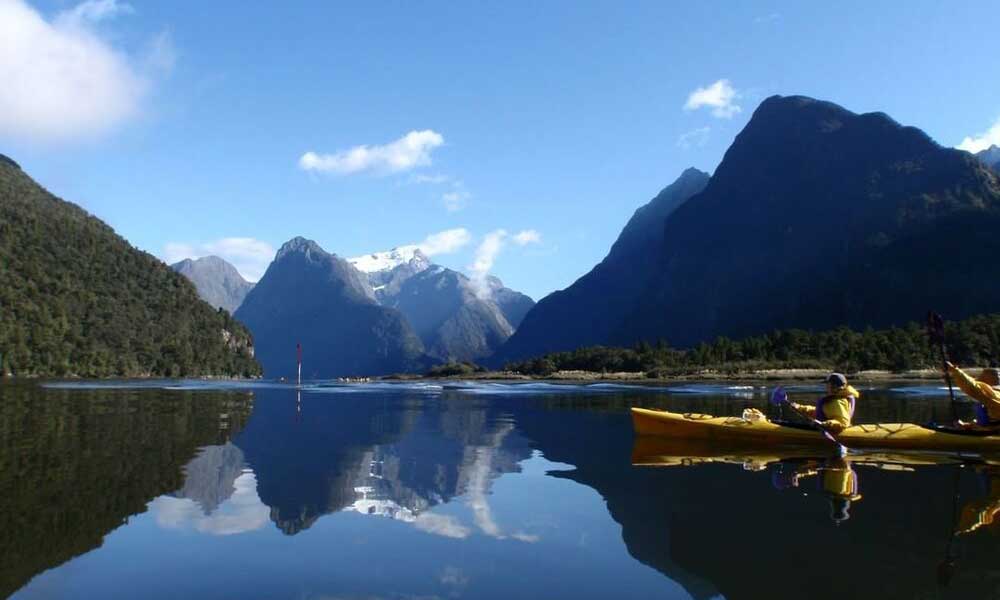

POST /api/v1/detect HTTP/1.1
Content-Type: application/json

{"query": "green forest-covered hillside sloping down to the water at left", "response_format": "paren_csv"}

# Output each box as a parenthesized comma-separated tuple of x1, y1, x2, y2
(0, 155, 260, 377)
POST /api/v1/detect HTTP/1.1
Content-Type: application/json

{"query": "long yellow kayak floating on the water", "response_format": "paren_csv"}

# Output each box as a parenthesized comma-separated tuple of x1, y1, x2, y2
(632, 408, 1000, 452)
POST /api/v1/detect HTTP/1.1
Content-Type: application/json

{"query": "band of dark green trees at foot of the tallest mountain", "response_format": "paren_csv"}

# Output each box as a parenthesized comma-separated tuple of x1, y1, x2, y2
(505, 314, 1000, 377)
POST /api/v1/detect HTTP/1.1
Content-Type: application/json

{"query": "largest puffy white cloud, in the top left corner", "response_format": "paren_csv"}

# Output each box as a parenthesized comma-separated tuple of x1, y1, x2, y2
(0, 0, 169, 143)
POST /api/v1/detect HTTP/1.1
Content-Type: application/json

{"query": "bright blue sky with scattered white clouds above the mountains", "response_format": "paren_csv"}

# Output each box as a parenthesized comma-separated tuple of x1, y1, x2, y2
(0, 0, 1000, 299)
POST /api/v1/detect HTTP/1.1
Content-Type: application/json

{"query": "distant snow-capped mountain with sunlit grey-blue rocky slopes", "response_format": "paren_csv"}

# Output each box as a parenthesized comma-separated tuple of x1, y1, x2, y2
(348, 246, 534, 361)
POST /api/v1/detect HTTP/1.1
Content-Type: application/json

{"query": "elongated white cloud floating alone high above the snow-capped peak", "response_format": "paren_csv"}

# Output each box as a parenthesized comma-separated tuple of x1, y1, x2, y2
(299, 129, 444, 175)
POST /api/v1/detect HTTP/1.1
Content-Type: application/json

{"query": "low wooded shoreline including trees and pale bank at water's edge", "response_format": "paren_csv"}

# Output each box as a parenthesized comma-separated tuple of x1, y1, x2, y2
(414, 314, 1000, 380)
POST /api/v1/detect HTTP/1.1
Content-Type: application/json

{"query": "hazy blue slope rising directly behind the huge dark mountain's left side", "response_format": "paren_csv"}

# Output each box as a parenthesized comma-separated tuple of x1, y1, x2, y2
(491, 169, 709, 365)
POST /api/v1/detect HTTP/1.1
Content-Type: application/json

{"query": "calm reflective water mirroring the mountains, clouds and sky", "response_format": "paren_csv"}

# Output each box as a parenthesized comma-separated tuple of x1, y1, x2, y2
(0, 382, 1000, 599)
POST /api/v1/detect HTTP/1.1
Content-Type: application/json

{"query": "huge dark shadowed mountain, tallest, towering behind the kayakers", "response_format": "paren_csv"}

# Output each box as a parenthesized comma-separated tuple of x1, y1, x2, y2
(624, 96, 1000, 346)
